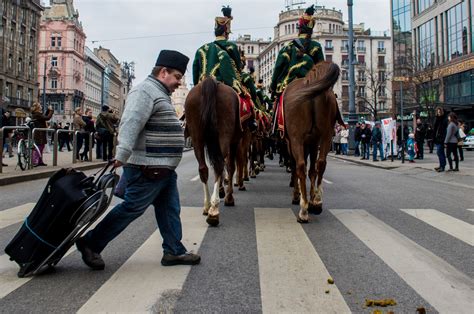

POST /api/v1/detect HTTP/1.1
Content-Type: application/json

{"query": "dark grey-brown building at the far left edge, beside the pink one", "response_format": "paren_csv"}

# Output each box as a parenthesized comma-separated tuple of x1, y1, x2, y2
(0, 0, 43, 118)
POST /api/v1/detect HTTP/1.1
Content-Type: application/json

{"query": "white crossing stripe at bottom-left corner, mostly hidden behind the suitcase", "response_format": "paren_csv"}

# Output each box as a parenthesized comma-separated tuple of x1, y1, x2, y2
(0, 206, 114, 300)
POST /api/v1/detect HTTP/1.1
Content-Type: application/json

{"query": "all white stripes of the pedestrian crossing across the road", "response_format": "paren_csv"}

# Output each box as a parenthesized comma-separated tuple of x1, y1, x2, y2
(0, 203, 474, 313)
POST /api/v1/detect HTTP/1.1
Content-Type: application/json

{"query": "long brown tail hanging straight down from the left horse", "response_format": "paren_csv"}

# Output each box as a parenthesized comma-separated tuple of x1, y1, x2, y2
(201, 77, 224, 171)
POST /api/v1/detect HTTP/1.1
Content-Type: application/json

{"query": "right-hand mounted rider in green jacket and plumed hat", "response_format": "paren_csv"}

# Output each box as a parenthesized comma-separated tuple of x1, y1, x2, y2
(270, 5, 324, 96)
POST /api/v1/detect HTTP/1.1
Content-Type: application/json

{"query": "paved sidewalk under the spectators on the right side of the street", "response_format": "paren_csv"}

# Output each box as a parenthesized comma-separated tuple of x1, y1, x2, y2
(329, 150, 474, 189)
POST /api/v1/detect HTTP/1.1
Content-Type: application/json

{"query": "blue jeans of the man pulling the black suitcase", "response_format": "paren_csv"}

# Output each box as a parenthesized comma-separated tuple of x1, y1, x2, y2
(85, 166, 186, 255)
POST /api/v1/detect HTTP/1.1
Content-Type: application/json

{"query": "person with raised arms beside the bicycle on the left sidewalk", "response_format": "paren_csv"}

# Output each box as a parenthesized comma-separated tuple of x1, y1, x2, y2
(31, 102, 54, 167)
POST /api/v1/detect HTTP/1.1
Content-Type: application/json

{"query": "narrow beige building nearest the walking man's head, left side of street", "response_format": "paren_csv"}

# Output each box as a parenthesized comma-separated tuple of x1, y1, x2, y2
(94, 47, 125, 115)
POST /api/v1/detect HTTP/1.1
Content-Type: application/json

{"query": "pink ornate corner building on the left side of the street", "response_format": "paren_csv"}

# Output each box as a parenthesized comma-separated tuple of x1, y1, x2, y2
(38, 0, 86, 122)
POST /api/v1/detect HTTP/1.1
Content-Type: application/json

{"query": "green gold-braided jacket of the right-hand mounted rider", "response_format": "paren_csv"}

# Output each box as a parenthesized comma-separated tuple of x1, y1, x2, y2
(270, 38, 324, 94)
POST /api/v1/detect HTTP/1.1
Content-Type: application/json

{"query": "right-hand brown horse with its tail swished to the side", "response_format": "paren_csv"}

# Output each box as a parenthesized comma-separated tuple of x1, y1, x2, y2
(284, 61, 344, 223)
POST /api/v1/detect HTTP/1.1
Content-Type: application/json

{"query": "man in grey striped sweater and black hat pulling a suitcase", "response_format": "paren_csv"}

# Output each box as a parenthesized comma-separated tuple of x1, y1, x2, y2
(76, 50, 201, 270)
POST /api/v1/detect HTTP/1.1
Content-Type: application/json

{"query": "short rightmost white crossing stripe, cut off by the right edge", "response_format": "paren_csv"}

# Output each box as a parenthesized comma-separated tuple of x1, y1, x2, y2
(400, 209, 474, 246)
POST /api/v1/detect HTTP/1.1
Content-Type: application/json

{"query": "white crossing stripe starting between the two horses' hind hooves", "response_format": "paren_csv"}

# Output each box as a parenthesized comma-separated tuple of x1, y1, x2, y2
(254, 208, 350, 313)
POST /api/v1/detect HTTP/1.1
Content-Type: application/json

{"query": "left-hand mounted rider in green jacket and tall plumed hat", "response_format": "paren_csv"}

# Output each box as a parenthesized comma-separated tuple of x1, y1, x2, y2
(193, 6, 256, 130)
